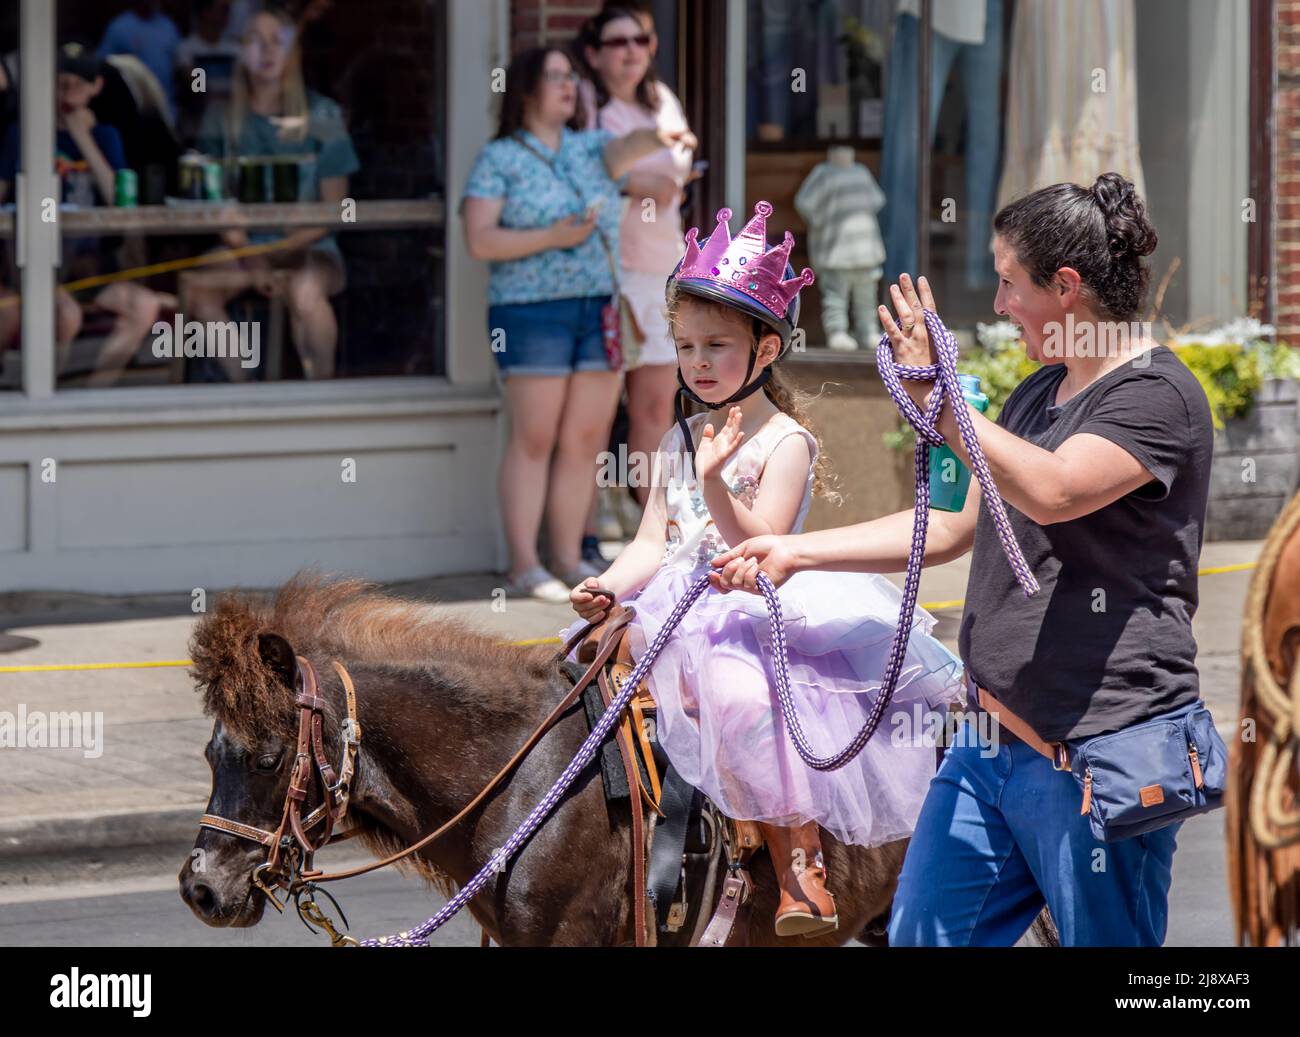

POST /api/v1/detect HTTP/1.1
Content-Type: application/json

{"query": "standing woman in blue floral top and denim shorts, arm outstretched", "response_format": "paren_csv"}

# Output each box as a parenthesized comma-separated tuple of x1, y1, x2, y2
(462, 47, 696, 602)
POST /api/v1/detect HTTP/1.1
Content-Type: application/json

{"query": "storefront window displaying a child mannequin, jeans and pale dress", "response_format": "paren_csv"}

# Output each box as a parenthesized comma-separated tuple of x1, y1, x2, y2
(746, 0, 1249, 351)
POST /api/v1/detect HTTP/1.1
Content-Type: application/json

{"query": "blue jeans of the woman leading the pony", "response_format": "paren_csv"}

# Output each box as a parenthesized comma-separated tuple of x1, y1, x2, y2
(889, 723, 1182, 947)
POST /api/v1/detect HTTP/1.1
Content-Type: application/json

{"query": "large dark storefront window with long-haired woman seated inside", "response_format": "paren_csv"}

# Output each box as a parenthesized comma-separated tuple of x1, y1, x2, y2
(16, 0, 446, 389)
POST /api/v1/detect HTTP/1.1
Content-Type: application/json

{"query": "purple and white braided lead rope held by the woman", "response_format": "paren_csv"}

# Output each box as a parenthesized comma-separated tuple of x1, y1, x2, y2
(361, 309, 1039, 947)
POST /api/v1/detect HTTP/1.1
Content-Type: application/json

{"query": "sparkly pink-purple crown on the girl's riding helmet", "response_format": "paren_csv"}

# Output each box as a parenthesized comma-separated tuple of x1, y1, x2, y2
(677, 201, 815, 318)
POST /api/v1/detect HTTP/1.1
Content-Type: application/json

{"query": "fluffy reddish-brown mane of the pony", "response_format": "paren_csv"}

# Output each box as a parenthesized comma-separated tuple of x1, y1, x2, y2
(190, 570, 555, 745)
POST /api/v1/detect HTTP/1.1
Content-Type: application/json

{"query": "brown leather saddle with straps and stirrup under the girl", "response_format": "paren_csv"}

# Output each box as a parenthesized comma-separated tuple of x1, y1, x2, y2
(562, 604, 763, 946)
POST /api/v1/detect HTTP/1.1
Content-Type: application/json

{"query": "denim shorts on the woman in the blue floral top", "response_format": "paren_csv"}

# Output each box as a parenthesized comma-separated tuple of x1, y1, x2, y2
(488, 295, 610, 378)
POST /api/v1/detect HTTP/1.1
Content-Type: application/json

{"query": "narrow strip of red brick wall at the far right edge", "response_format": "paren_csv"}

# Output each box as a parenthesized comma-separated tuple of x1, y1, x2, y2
(1274, 0, 1300, 346)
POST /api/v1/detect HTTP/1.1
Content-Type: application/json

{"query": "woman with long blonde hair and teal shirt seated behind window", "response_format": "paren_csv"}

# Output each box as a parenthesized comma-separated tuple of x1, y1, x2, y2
(183, 10, 360, 379)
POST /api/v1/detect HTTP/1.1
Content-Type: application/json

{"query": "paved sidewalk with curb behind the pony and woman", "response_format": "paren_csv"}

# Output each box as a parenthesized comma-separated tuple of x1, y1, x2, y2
(0, 542, 1260, 886)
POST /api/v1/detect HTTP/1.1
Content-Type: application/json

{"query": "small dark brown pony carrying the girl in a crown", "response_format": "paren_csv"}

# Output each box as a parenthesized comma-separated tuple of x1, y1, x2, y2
(179, 574, 1045, 946)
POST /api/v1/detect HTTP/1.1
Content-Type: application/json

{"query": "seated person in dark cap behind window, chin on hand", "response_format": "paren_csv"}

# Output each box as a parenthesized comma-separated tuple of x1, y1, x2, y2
(0, 44, 160, 386)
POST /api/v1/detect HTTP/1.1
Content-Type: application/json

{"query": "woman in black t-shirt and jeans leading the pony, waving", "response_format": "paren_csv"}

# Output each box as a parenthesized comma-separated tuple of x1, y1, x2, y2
(714, 173, 1212, 946)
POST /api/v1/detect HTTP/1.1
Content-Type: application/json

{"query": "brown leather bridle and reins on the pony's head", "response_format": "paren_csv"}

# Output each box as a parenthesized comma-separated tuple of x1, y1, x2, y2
(199, 605, 634, 946)
